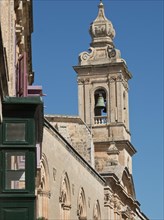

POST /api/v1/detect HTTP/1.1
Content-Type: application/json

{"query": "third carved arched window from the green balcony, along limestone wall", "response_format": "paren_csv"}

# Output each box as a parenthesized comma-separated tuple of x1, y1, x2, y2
(77, 188, 87, 220)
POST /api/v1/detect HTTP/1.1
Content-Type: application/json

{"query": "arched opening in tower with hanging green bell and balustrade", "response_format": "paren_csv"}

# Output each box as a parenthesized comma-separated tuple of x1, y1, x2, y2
(94, 89, 107, 124)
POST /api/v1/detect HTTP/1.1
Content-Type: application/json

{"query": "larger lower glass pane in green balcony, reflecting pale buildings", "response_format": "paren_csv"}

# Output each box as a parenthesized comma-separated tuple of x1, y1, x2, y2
(5, 152, 26, 189)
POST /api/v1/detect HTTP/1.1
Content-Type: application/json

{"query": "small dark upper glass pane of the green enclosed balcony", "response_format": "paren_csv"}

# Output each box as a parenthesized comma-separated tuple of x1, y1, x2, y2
(6, 123, 26, 141)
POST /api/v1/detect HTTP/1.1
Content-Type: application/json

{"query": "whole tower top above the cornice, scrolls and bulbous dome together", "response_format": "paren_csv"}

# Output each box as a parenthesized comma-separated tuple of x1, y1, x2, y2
(79, 1, 123, 66)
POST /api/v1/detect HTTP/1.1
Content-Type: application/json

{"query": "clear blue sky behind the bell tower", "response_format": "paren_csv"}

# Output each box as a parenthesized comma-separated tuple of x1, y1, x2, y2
(32, 0, 164, 220)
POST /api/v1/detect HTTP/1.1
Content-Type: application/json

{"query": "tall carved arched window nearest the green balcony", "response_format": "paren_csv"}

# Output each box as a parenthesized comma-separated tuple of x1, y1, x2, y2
(37, 154, 50, 220)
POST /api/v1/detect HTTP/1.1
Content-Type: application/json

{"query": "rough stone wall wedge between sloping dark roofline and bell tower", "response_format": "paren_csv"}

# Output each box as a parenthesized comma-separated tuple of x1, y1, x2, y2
(46, 115, 93, 164)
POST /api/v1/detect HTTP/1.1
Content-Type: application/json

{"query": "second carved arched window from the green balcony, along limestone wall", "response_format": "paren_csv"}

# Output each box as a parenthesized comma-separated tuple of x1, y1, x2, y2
(59, 173, 71, 220)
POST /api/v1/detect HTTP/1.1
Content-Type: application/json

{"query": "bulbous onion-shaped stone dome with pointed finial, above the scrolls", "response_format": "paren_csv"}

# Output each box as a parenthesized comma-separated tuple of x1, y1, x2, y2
(90, 1, 115, 46)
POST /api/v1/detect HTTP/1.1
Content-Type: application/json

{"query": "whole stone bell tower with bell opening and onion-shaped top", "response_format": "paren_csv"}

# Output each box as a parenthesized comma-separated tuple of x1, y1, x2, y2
(74, 1, 136, 174)
